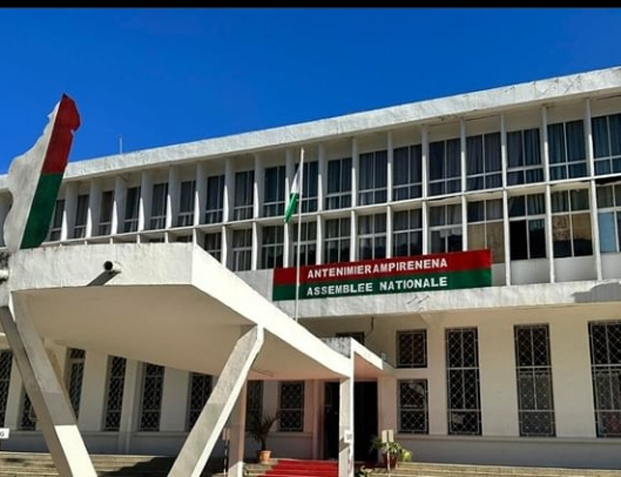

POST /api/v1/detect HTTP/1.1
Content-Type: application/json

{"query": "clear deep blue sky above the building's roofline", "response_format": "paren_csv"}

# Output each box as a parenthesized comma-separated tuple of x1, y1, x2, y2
(0, 8, 621, 173)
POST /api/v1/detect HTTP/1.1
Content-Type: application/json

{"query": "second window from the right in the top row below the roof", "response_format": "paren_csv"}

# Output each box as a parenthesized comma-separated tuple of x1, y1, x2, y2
(548, 119, 587, 180)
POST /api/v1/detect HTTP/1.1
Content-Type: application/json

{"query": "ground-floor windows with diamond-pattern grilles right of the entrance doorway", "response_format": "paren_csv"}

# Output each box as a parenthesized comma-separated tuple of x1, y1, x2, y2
(397, 321, 621, 437)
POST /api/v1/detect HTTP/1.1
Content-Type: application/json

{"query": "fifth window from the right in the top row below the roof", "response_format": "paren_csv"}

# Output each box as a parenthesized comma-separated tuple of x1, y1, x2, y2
(429, 139, 461, 196)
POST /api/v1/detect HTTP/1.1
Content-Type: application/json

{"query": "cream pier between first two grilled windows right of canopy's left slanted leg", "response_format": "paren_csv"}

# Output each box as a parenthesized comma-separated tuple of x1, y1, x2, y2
(78, 351, 108, 431)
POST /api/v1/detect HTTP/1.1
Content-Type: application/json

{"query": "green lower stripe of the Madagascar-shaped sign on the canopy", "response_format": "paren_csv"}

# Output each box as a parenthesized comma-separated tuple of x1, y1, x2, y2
(20, 173, 63, 249)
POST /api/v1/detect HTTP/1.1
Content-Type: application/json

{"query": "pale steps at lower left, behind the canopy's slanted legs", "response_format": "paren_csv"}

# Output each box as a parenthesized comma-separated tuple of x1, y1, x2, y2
(0, 452, 222, 477)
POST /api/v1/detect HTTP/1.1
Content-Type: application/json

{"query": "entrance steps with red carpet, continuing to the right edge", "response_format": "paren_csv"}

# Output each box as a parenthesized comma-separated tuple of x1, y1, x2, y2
(246, 459, 621, 477)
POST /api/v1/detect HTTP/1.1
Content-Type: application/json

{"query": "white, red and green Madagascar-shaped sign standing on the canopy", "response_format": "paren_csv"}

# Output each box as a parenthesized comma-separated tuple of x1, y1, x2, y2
(4, 94, 80, 253)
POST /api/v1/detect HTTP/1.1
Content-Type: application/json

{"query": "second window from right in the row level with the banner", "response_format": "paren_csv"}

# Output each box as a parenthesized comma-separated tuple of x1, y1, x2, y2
(552, 189, 593, 258)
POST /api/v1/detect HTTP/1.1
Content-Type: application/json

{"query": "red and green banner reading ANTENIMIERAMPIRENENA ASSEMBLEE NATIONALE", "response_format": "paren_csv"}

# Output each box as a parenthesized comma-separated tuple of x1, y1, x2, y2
(272, 249, 492, 301)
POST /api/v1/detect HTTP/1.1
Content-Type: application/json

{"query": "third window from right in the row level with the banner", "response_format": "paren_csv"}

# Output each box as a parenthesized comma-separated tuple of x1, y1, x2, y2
(509, 194, 547, 260)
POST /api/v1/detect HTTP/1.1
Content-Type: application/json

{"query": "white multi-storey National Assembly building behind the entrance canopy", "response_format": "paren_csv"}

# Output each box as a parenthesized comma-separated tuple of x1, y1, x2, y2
(0, 67, 621, 468)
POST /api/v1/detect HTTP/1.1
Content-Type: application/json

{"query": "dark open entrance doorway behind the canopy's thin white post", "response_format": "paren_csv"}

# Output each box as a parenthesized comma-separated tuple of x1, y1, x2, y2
(323, 382, 377, 462)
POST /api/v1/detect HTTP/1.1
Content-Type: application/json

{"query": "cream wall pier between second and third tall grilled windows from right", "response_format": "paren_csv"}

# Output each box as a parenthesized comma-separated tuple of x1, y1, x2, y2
(478, 320, 520, 436)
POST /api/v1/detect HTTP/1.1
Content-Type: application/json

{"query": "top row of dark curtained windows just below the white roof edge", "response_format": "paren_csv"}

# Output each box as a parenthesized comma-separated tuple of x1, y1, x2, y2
(43, 114, 621, 241)
